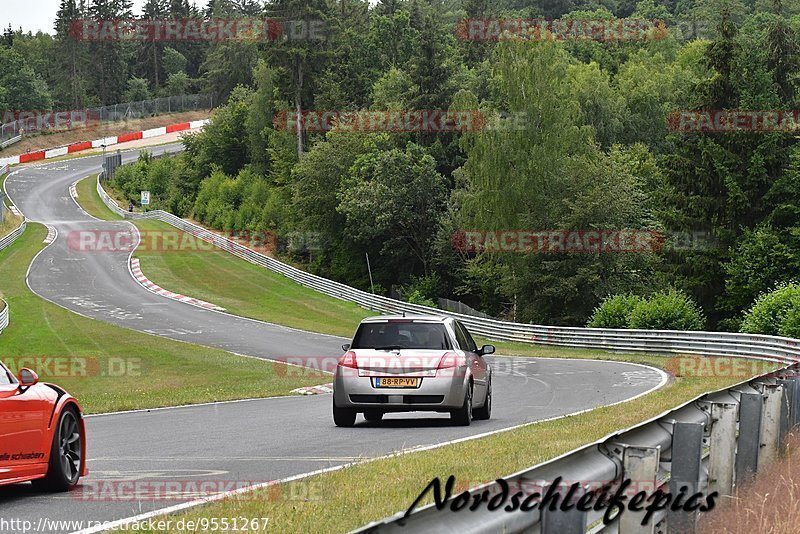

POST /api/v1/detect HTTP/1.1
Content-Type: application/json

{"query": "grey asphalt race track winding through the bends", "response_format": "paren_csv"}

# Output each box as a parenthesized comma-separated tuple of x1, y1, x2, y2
(0, 149, 664, 531)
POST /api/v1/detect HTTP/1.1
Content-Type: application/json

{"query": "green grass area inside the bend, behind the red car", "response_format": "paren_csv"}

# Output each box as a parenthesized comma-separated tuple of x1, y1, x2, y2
(0, 223, 328, 413)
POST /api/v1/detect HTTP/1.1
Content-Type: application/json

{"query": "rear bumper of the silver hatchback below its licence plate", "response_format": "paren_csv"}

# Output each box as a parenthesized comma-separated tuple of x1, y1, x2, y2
(333, 372, 469, 412)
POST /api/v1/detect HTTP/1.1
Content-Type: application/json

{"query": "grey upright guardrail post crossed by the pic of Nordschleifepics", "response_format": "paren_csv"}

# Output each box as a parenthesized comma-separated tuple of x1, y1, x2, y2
(667, 421, 705, 534)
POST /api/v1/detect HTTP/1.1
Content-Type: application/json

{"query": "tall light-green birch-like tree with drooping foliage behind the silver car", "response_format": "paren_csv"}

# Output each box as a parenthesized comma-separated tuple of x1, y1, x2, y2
(451, 42, 658, 324)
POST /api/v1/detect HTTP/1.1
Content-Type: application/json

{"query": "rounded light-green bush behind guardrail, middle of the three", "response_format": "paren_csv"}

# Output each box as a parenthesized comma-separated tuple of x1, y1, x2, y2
(628, 289, 706, 330)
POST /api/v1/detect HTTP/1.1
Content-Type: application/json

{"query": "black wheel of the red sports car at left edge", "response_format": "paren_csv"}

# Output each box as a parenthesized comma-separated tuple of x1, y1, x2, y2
(34, 407, 83, 491)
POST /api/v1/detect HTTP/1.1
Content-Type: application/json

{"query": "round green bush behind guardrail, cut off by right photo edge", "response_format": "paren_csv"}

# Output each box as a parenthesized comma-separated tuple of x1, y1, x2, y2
(740, 283, 800, 337)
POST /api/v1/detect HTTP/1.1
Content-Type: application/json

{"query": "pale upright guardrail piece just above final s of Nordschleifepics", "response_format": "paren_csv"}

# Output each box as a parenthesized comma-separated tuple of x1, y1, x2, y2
(708, 402, 738, 496)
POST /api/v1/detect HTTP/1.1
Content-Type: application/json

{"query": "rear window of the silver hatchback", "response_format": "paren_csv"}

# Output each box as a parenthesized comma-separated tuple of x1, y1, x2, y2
(351, 321, 451, 350)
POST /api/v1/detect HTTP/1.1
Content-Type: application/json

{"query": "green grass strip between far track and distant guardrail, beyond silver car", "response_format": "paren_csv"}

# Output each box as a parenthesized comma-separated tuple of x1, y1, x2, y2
(78, 176, 376, 337)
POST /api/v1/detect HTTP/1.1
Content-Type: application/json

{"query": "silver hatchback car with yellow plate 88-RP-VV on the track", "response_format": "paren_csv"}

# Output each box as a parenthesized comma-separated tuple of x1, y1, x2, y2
(333, 316, 494, 427)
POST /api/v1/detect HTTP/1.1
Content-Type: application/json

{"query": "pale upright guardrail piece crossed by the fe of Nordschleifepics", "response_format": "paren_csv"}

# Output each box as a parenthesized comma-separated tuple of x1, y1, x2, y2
(619, 447, 661, 534)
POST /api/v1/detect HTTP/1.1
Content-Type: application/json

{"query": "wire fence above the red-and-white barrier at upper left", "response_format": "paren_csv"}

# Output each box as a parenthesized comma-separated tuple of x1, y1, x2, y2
(0, 94, 215, 144)
